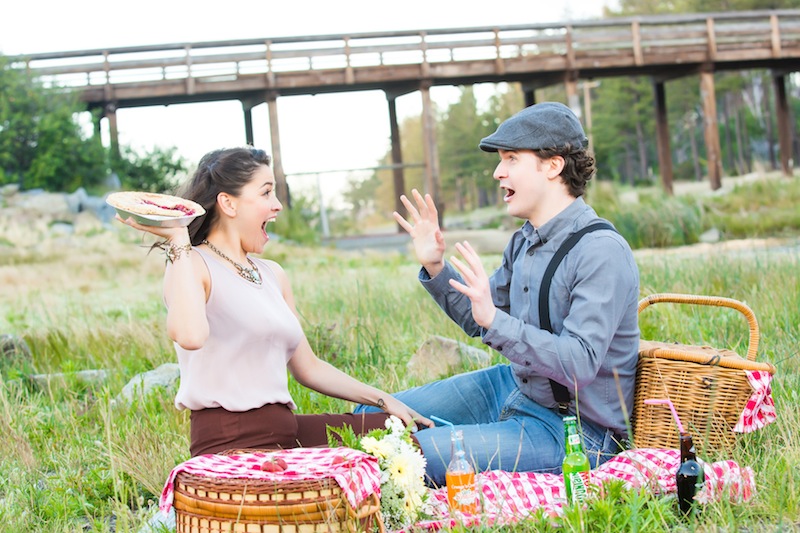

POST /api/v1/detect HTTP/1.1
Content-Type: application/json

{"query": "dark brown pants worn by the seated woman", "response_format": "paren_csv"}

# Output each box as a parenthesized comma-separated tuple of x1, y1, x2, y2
(190, 404, 389, 457)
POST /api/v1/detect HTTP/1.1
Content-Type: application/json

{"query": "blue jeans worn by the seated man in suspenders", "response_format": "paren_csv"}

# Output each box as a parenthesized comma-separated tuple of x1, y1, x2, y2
(354, 365, 619, 486)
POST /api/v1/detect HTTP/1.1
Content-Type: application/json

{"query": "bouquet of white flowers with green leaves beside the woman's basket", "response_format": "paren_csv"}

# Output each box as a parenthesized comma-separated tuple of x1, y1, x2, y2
(328, 416, 433, 531)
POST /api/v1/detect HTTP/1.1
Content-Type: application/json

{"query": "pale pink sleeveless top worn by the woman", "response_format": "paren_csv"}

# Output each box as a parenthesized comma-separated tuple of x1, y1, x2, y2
(175, 248, 303, 411)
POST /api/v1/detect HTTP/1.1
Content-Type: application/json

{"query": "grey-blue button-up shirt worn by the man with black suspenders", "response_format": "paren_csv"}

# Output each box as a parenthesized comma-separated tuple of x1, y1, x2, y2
(419, 198, 639, 436)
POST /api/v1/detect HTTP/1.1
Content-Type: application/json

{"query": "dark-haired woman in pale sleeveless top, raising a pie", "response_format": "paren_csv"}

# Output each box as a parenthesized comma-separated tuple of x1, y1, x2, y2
(117, 148, 433, 456)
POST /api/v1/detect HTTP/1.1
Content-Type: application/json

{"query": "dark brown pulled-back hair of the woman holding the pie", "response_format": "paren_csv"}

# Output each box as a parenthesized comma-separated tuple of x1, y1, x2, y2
(178, 147, 271, 246)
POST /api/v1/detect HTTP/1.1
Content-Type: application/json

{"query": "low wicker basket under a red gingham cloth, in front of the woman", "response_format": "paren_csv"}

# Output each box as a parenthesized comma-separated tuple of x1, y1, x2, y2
(174, 450, 385, 533)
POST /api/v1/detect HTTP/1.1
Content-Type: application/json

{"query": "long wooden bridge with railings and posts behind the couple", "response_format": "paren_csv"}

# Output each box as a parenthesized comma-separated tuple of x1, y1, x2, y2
(12, 10, 800, 212)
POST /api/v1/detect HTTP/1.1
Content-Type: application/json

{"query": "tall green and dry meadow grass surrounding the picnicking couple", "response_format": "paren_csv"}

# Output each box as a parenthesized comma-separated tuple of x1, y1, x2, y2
(0, 183, 800, 532)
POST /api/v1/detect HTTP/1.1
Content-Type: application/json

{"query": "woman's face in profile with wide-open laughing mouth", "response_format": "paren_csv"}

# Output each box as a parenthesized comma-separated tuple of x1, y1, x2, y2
(235, 165, 283, 254)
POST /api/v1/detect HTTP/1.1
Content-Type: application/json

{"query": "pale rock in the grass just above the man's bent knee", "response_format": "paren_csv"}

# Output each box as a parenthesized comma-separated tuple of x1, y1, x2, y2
(406, 335, 491, 381)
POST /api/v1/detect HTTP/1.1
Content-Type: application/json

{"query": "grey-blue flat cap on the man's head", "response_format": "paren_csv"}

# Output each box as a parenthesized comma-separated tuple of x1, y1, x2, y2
(479, 102, 588, 152)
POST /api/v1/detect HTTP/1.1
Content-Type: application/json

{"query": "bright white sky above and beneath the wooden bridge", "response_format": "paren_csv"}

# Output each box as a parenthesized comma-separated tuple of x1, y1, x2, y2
(0, 0, 616, 201)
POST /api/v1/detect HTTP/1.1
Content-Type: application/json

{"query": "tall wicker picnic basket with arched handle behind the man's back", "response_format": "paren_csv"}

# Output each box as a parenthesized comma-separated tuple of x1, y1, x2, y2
(632, 294, 775, 453)
